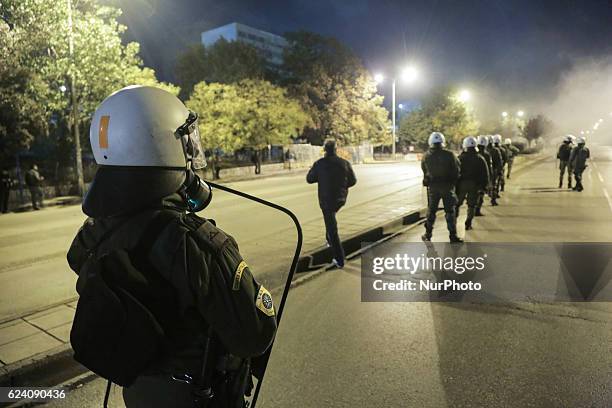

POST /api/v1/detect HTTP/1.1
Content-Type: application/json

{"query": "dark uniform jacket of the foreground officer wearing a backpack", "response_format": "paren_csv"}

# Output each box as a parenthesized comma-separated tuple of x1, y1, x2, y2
(67, 195, 275, 375)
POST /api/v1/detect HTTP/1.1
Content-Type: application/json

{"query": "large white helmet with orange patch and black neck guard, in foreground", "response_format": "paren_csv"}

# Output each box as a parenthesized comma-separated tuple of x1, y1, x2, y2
(83, 86, 210, 217)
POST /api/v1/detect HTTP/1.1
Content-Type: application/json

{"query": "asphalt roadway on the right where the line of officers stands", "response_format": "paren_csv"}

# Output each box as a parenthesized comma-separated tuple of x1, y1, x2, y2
(46, 149, 612, 408)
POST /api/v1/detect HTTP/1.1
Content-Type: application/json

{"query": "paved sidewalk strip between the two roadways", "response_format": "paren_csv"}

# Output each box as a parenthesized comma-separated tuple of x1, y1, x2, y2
(0, 157, 537, 386)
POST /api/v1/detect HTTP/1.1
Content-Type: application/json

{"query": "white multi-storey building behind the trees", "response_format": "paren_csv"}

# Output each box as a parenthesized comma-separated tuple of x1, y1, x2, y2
(201, 23, 287, 67)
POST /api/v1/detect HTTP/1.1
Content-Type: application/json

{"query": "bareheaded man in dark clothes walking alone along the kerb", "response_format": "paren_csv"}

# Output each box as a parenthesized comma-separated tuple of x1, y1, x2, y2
(306, 140, 357, 268)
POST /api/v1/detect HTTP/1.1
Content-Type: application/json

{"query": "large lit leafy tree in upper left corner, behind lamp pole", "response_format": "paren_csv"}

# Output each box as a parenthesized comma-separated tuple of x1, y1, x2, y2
(0, 0, 178, 164)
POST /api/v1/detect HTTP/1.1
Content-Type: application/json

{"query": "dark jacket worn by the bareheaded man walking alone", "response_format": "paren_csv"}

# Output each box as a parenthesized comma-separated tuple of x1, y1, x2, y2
(306, 154, 357, 211)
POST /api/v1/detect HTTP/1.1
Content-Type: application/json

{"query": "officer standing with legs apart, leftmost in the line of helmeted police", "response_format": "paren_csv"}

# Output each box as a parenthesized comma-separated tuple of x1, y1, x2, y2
(421, 132, 463, 243)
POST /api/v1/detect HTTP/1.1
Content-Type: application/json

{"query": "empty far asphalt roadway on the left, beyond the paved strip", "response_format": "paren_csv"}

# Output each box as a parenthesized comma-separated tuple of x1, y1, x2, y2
(0, 163, 421, 321)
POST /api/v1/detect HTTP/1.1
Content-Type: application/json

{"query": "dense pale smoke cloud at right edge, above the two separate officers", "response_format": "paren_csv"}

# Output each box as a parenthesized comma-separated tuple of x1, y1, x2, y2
(535, 57, 612, 144)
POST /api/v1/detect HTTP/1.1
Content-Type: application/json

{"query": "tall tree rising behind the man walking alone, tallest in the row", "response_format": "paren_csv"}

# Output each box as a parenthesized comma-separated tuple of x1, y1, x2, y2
(281, 31, 389, 144)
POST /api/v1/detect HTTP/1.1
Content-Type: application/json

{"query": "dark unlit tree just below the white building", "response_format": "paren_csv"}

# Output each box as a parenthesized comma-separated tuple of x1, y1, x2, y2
(176, 38, 266, 99)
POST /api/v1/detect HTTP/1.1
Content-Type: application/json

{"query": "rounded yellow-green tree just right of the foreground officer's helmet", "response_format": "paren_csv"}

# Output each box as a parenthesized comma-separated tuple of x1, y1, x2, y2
(186, 79, 309, 151)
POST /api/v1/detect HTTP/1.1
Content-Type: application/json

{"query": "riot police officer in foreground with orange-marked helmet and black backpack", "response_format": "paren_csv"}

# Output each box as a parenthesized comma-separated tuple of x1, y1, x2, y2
(68, 86, 276, 407)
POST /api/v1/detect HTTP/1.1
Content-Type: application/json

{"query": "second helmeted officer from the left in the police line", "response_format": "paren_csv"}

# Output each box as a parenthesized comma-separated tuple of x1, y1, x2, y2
(456, 136, 489, 231)
